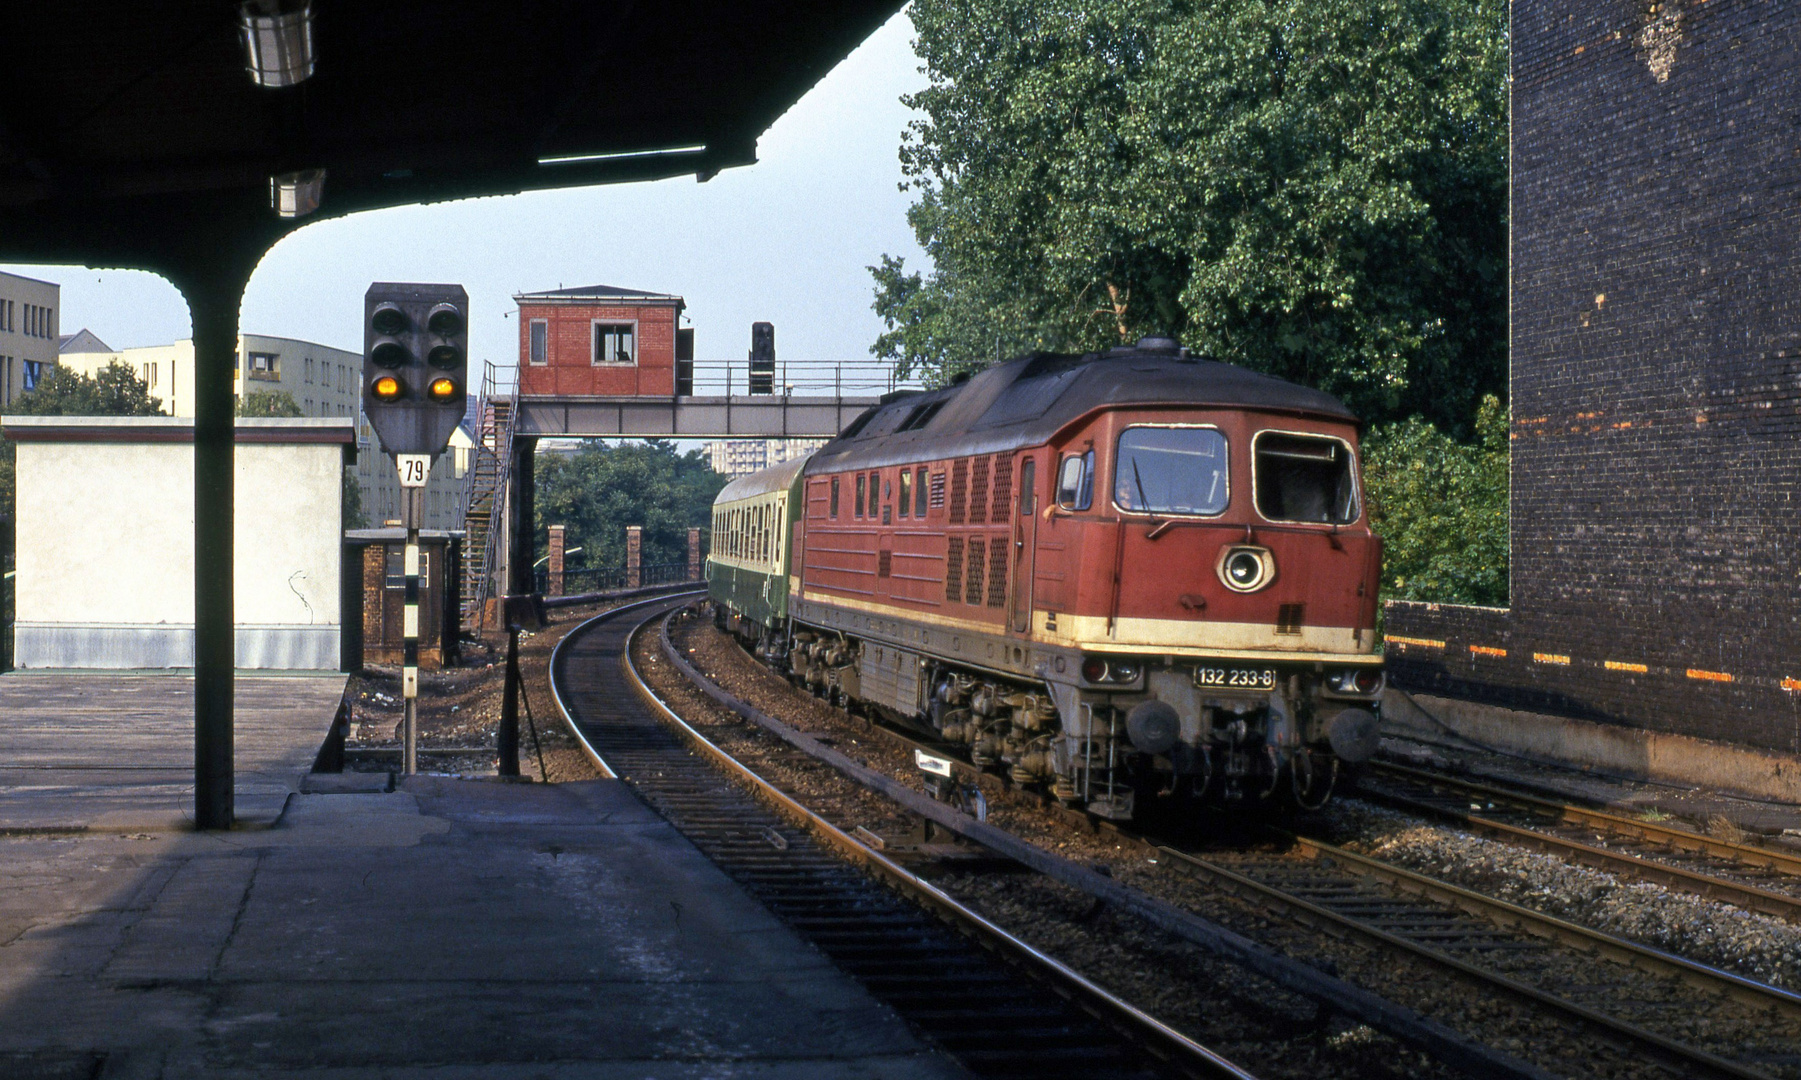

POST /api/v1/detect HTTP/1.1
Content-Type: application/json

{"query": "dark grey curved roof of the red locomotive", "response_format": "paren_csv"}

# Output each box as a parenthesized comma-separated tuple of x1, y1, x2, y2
(807, 344, 1358, 475)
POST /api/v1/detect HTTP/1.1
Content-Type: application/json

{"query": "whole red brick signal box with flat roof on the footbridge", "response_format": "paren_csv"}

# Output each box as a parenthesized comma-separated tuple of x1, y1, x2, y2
(513, 284, 693, 398)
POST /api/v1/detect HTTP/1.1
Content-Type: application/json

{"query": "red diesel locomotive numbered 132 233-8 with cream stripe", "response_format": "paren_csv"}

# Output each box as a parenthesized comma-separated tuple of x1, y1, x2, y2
(713, 338, 1383, 817)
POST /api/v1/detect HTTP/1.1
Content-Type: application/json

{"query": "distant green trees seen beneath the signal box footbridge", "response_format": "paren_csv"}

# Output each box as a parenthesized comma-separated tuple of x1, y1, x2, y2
(533, 439, 726, 567)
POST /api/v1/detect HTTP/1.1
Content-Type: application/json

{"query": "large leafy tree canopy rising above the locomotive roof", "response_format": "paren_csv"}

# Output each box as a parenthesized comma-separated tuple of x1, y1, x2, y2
(870, 0, 1507, 436)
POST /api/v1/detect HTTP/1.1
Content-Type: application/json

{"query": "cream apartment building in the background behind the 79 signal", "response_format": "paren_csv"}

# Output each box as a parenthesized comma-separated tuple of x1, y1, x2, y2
(61, 333, 474, 531)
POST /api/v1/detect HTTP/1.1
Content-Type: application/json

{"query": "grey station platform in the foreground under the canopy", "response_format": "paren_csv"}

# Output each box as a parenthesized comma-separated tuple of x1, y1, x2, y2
(0, 677, 965, 1080)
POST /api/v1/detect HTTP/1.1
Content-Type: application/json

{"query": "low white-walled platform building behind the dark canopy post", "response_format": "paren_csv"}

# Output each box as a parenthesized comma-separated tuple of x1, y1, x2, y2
(0, 416, 360, 671)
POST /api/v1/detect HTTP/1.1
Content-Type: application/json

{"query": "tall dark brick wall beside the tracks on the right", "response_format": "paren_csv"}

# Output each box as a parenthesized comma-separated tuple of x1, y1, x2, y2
(1387, 0, 1801, 751)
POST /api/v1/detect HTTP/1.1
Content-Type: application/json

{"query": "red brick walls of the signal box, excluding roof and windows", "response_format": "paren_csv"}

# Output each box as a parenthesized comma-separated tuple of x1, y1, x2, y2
(519, 301, 677, 396)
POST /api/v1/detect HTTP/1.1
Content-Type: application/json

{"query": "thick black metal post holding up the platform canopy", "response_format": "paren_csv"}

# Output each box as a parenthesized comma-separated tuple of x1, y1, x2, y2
(182, 281, 243, 830)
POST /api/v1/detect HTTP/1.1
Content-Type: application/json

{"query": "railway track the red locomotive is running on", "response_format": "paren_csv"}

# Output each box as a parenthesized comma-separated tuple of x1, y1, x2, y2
(655, 608, 1801, 1078)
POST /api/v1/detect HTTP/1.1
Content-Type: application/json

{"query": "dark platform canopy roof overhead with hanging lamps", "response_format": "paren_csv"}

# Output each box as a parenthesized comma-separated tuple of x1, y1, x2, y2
(0, 0, 901, 284)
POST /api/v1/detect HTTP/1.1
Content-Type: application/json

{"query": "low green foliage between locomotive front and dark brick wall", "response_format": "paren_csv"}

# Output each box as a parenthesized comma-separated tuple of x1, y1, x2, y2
(1363, 396, 1507, 607)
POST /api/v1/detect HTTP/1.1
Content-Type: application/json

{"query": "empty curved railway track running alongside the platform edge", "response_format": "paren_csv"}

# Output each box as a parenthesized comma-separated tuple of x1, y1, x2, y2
(551, 598, 1250, 1080)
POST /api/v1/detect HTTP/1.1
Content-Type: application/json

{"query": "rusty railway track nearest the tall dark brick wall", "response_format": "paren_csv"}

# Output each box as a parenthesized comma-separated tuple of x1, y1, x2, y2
(1358, 763, 1801, 925)
